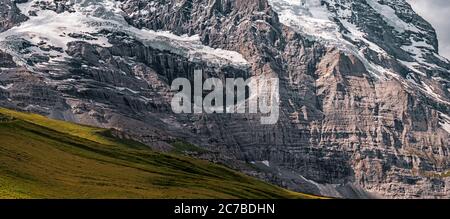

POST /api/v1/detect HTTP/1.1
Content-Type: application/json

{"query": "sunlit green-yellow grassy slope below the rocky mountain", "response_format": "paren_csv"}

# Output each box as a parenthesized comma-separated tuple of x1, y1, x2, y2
(0, 108, 320, 198)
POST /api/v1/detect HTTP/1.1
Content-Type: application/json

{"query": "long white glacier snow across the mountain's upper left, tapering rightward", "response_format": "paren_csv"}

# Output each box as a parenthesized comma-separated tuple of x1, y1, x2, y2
(0, 0, 249, 68)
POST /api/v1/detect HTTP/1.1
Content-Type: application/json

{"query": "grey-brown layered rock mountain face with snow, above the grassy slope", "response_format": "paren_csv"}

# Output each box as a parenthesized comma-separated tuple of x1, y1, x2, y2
(0, 0, 450, 198)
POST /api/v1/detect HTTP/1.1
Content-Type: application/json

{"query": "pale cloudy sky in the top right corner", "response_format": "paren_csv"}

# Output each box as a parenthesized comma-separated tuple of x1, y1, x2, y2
(408, 0, 450, 59)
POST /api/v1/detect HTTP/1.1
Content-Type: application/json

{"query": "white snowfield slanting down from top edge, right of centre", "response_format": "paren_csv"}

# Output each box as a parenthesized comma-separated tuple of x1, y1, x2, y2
(269, 0, 392, 79)
